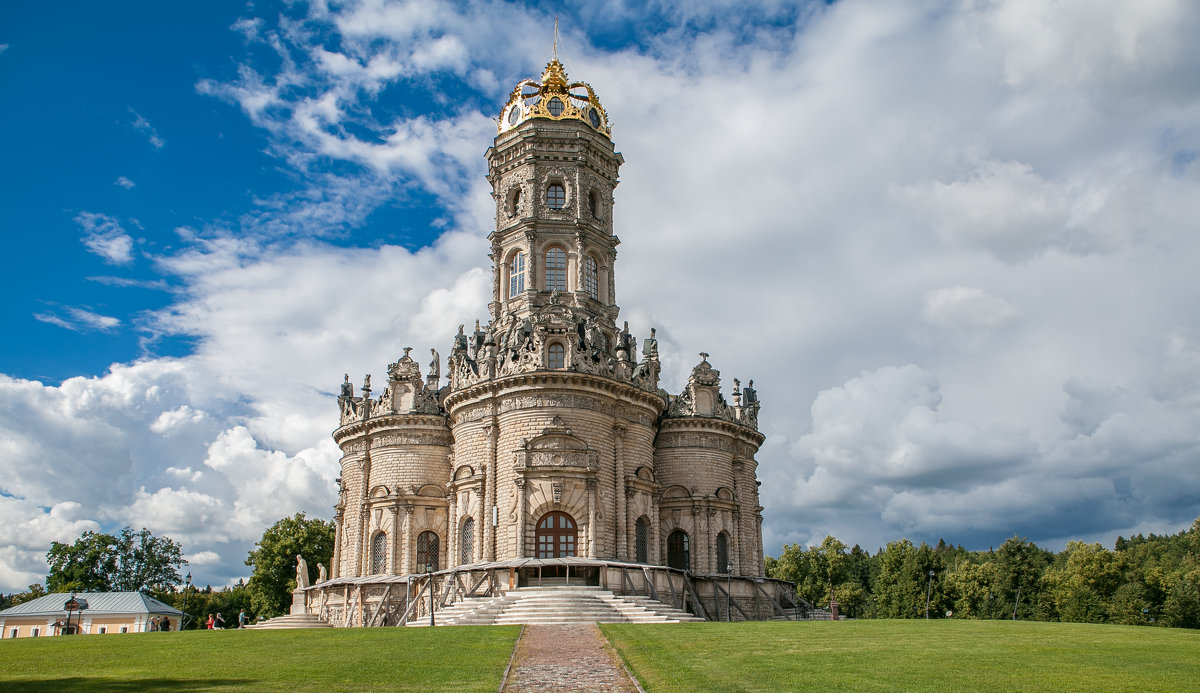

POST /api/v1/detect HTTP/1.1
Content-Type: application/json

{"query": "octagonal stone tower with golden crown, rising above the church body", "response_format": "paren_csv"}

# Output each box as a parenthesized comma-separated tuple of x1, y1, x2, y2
(486, 58, 624, 324)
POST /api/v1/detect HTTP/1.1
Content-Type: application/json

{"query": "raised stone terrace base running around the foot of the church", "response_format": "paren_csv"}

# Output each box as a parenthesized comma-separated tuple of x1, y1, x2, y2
(302, 558, 806, 627)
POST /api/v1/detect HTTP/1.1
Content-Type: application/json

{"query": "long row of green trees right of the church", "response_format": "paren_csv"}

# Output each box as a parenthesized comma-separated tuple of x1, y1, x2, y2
(767, 518, 1200, 628)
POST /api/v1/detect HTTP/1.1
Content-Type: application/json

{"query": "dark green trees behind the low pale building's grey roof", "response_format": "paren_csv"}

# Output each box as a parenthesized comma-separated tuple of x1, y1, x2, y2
(46, 528, 187, 592)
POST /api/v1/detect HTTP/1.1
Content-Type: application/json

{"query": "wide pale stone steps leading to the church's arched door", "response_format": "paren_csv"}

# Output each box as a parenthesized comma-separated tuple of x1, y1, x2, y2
(408, 586, 703, 627)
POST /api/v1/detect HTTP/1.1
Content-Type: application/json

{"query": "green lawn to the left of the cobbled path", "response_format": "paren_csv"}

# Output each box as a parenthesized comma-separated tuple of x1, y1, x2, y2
(0, 626, 521, 693)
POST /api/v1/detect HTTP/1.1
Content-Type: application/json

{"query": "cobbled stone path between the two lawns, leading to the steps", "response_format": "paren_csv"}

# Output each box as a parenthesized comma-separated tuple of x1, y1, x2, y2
(504, 623, 641, 693)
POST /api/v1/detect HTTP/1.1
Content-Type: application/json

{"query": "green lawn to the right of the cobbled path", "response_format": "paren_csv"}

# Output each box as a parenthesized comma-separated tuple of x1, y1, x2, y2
(601, 620, 1200, 693)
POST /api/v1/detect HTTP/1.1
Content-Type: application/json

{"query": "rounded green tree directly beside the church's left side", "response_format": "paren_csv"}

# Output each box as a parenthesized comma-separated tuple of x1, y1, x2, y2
(246, 512, 334, 619)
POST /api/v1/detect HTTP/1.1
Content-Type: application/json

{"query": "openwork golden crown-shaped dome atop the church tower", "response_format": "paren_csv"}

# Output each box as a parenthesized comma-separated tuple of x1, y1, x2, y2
(499, 58, 612, 137)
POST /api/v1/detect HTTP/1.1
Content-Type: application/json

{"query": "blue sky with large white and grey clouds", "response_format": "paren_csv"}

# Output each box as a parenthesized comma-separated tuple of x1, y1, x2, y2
(0, 0, 1200, 591)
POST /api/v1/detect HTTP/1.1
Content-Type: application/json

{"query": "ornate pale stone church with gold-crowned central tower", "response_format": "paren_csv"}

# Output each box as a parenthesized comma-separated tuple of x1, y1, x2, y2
(306, 58, 791, 625)
